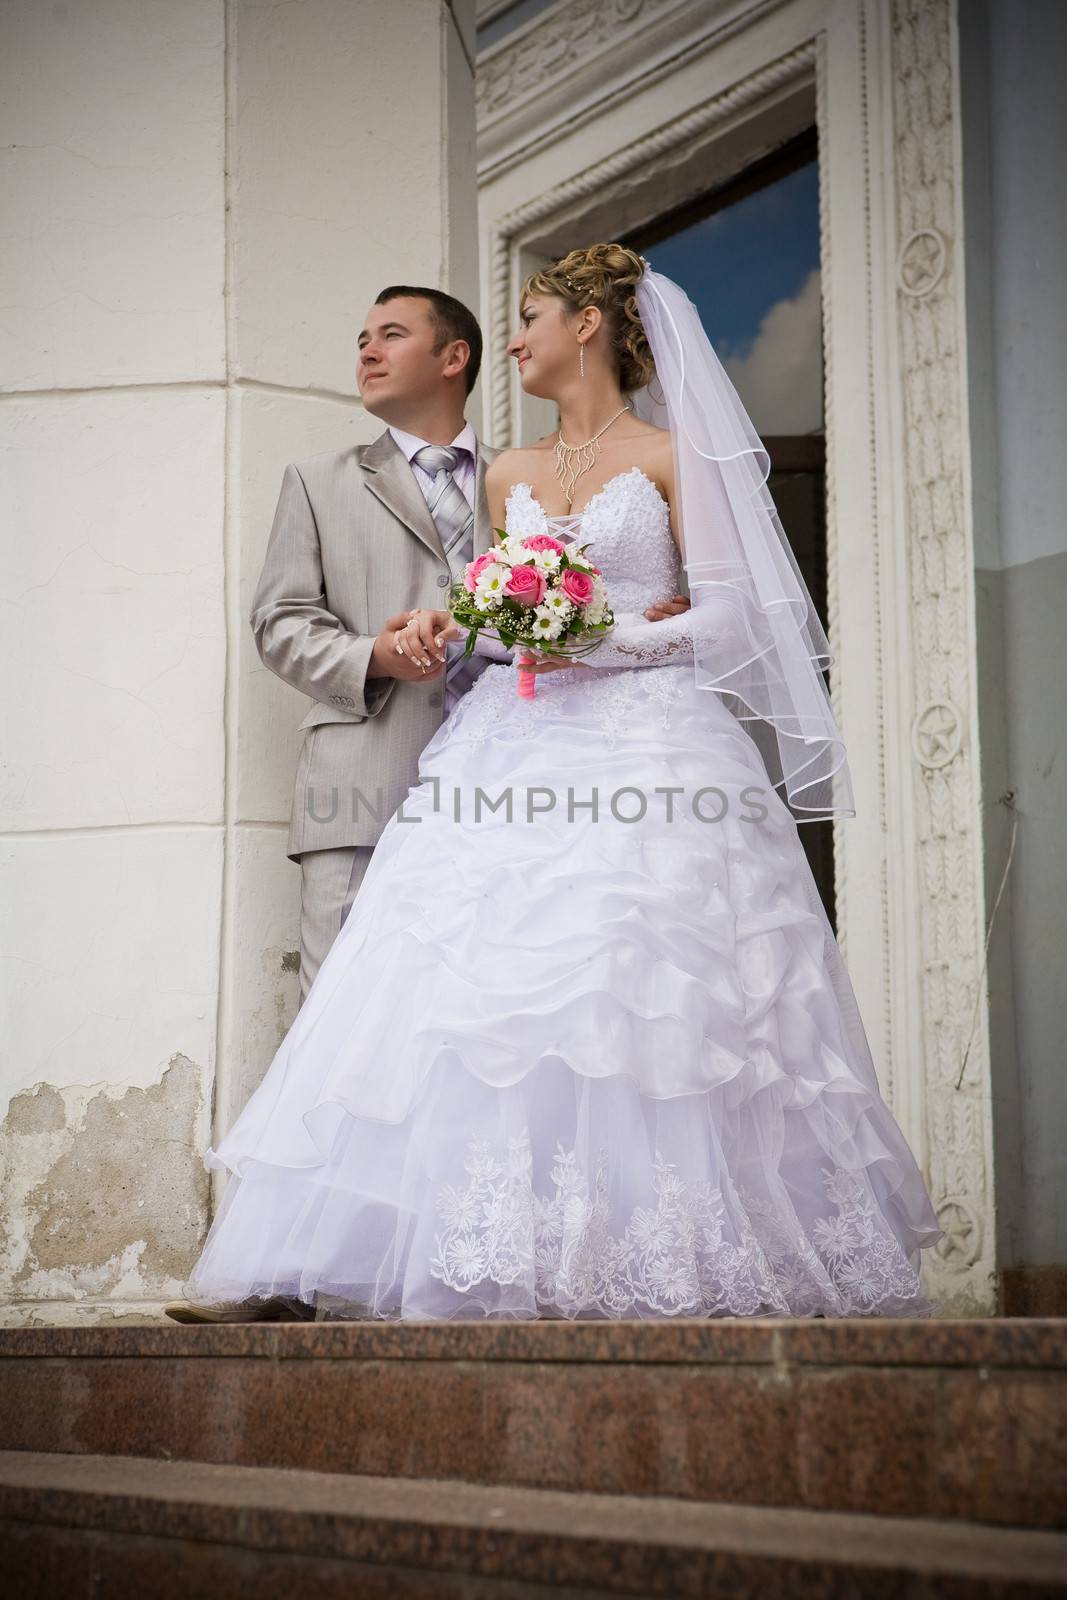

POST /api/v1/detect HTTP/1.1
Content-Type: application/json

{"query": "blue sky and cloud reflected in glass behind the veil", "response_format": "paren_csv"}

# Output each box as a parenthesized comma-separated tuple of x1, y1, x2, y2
(641, 162, 822, 434)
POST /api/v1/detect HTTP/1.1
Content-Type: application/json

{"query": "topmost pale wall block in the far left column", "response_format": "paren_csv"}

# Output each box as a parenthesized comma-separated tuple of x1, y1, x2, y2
(0, 0, 226, 390)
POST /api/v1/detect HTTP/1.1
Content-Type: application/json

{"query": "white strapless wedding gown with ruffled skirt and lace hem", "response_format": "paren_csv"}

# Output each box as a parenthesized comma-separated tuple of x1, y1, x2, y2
(186, 467, 941, 1318)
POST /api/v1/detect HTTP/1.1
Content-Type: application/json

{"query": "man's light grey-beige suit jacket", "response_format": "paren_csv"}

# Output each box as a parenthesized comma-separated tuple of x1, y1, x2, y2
(250, 432, 498, 861)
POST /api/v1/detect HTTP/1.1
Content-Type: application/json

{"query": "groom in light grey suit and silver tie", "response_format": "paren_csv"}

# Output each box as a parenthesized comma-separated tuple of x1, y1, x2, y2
(251, 285, 688, 1003)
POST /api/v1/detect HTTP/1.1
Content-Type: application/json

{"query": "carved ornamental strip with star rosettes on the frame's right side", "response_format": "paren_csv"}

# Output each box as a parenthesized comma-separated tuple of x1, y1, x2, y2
(891, 0, 995, 1309)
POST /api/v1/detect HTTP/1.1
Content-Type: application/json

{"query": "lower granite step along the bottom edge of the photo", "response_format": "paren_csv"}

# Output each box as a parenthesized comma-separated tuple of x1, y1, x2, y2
(0, 1451, 1067, 1600)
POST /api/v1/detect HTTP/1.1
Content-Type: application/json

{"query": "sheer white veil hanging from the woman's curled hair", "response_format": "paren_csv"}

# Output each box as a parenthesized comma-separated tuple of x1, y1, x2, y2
(633, 258, 856, 822)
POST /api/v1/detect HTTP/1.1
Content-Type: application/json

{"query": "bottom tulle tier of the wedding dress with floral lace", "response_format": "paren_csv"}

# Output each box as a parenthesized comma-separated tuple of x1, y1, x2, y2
(187, 1061, 931, 1320)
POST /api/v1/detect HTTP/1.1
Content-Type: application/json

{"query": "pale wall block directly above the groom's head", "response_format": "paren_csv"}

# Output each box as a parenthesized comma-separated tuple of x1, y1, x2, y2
(230, 0, 451, 394)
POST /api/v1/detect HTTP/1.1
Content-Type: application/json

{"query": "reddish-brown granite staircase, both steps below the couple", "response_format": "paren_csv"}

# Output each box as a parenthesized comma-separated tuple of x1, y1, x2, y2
(0, 1318, 1067, 1600)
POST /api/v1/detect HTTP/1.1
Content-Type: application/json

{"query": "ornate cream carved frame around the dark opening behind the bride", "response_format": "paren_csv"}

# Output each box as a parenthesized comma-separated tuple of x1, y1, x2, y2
(478, 0, 995, 1312)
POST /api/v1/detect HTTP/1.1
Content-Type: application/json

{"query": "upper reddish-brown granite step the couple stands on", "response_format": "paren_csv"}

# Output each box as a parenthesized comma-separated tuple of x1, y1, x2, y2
(0, 1318, 1067, 1528)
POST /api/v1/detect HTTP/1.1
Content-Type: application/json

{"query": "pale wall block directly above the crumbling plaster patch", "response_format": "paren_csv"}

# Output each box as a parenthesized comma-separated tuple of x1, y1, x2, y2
(0, 829, 222, 1102)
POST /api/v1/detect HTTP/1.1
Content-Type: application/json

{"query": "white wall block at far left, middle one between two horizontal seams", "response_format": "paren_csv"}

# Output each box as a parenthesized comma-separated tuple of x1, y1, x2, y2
(0, 389, 226, 830)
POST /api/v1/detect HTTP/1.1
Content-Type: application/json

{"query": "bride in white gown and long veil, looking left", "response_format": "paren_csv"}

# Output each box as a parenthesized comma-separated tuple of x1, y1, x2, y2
(171, 245, 941, 1320)
